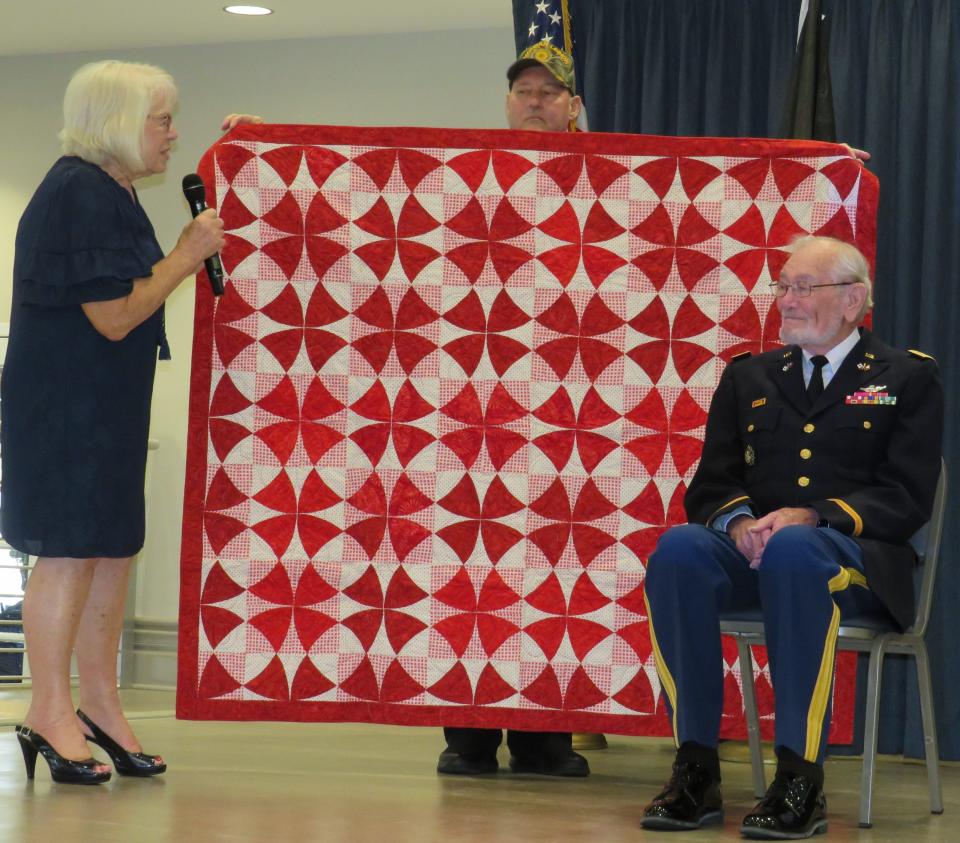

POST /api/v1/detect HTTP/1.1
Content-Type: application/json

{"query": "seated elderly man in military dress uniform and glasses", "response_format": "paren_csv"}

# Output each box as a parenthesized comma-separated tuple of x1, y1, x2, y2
(642, 237, 943, 839)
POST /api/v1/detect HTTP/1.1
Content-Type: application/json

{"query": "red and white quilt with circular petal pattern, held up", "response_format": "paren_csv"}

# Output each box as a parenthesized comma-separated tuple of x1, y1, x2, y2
(177, 126, 877, 740)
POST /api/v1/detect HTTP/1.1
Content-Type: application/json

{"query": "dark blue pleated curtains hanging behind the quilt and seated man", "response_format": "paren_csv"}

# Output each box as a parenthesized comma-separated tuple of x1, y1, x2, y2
(513, 0, 960, 759)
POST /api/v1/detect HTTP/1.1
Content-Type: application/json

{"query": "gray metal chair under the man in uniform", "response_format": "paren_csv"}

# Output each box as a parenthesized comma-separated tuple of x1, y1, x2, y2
(720, 460, 947, 828)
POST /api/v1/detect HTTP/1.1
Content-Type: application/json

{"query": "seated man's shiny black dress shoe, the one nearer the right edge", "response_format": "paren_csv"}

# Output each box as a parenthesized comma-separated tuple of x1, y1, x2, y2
(740, 770, 827, 840)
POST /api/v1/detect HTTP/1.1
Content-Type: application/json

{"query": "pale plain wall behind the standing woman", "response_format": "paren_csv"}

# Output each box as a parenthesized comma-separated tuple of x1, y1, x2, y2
(0, 29, 514, 620)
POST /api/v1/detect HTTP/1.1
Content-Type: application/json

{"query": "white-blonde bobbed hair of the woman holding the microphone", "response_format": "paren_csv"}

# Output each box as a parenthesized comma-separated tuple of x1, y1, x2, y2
(60, 60, 177, 174)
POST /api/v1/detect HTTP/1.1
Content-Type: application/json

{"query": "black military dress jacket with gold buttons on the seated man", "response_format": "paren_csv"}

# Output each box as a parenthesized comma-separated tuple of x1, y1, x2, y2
(684, 329, 943, 628)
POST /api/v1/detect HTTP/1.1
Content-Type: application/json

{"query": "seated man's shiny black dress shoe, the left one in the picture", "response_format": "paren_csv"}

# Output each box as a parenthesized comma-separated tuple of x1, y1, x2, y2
(640, 760, 723, 831)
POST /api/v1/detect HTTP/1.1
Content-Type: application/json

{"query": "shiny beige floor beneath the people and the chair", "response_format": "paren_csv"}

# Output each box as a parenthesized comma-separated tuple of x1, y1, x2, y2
(0, 689, 960, 843)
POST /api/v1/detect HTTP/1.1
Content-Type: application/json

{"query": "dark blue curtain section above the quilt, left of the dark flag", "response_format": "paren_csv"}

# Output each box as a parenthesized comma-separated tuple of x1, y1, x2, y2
(513, 0, 800, 137)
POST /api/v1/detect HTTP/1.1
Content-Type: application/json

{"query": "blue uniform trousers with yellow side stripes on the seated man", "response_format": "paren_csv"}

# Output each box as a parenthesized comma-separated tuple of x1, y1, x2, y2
(645, 524, 884, 763)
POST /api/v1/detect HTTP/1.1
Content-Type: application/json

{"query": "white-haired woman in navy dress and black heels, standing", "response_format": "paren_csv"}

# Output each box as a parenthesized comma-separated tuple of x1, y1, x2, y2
(0, 61, 223, 784)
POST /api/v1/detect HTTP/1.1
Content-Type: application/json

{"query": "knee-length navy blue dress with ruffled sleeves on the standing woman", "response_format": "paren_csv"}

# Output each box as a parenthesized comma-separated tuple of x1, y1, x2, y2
(0, 156, 169, 558)
